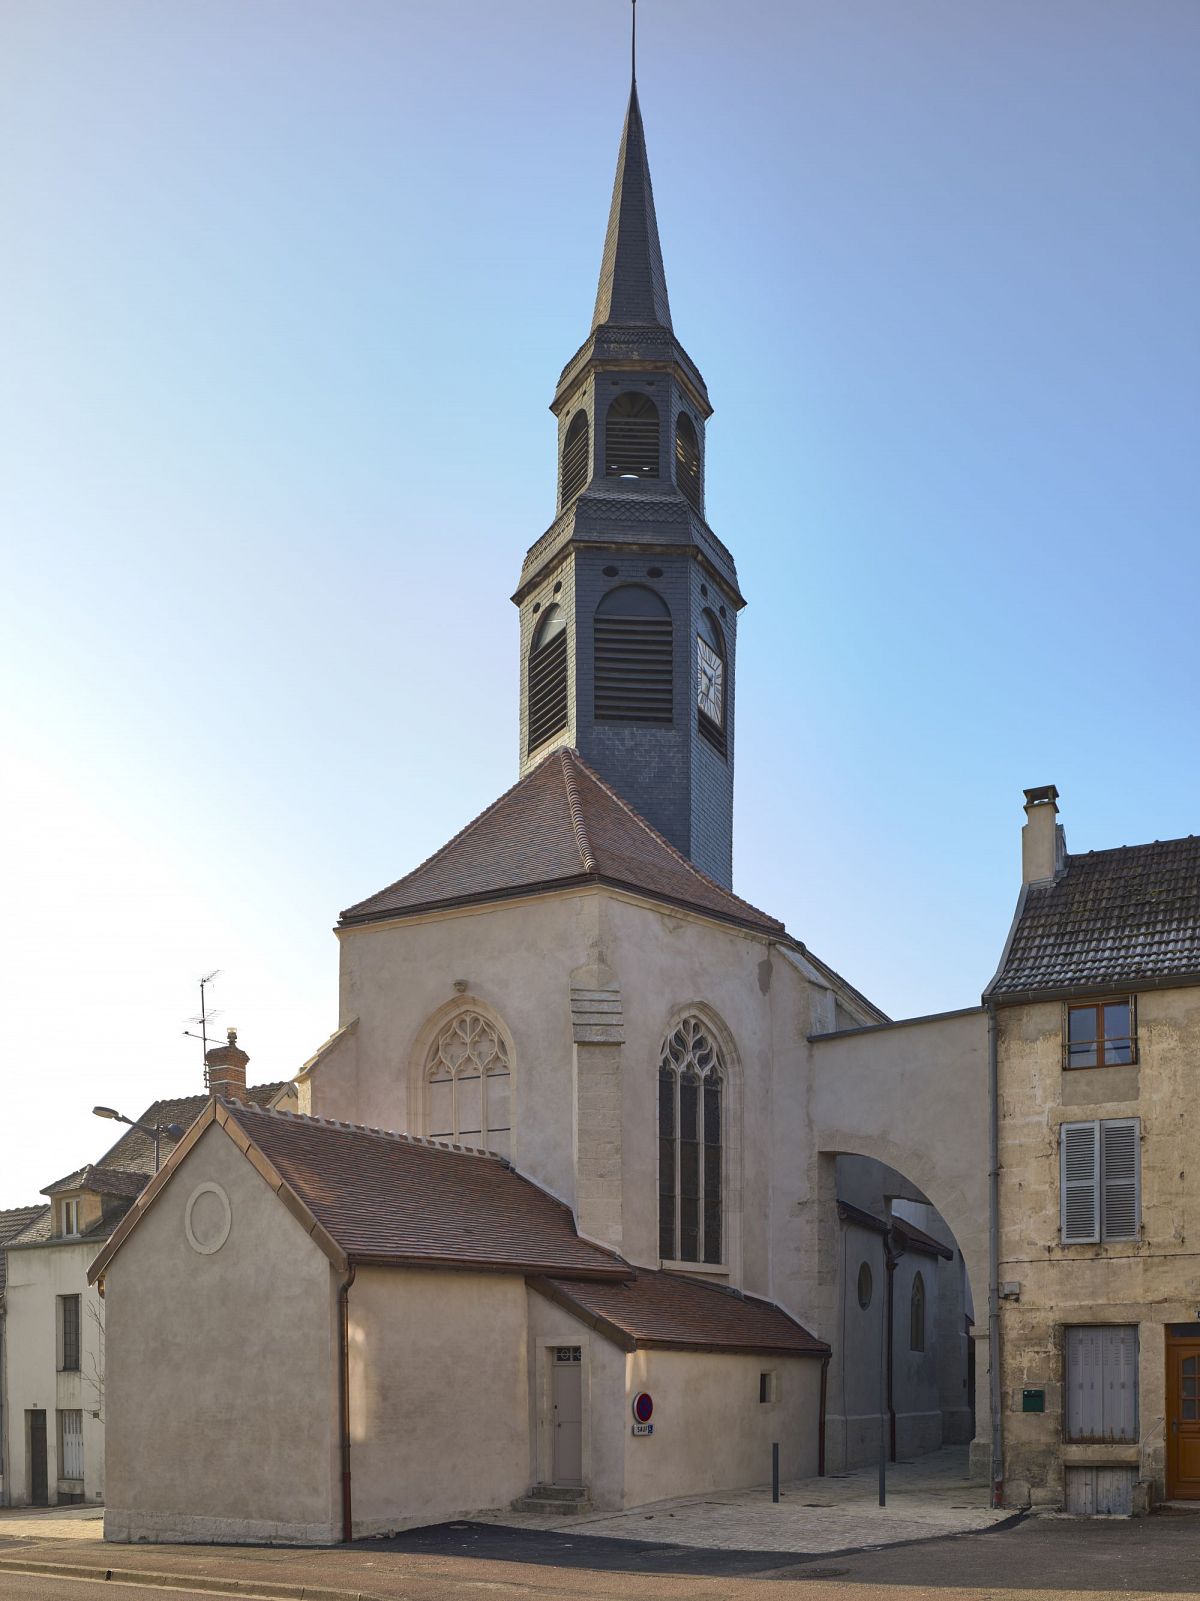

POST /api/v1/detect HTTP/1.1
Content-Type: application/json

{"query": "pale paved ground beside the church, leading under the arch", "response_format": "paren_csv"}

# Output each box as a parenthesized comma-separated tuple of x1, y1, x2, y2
(474, 1446, 1013, 1553)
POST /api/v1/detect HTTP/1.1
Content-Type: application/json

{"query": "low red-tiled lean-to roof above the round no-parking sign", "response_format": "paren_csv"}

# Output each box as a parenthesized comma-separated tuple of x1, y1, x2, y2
(531, 1271, 829, 1356)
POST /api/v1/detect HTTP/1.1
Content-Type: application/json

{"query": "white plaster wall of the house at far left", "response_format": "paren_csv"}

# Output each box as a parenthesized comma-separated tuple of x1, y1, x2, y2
(3, 1241, 106, 1507)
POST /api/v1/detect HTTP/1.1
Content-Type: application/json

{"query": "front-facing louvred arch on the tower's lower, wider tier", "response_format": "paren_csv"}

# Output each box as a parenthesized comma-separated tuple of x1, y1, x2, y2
(592, 584, 675, 724)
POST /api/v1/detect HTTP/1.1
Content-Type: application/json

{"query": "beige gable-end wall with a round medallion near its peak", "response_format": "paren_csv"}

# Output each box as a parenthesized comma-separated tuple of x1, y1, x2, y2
(104, 1126, 341, 1543)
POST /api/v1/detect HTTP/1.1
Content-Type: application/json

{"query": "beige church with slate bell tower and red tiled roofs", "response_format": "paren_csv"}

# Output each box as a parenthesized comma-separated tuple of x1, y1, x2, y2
(91, 59, 982, 1543)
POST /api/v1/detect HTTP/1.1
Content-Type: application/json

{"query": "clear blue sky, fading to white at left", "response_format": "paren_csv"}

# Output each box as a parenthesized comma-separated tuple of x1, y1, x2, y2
(0, 0, 1200, 1206)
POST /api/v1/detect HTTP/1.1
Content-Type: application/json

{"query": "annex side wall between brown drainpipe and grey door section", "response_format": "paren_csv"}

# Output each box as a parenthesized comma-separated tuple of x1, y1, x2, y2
(349, 1268, 530, 1537)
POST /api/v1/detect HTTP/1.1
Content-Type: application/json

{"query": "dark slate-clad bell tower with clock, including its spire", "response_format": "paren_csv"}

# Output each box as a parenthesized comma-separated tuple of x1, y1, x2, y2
(512, 68, 746, 889)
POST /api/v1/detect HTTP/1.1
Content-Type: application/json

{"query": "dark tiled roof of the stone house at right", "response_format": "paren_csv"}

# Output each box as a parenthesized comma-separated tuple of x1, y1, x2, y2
(984, 834, 1200, 1001)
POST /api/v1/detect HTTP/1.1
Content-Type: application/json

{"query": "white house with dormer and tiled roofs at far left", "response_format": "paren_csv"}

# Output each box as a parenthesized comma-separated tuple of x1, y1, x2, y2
(0, 1069, 294, 1507)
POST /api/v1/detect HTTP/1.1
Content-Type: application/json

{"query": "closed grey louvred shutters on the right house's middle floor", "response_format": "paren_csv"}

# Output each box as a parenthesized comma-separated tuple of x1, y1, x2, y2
(1059, 1117, 1142, 1246)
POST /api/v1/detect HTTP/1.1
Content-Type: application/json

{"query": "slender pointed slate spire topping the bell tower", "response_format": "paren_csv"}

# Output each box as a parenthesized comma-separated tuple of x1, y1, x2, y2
(592, 83, 670, 328)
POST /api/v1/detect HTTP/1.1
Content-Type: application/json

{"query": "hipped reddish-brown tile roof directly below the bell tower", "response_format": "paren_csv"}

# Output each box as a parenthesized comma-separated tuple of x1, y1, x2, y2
(341, 749, 786, 935)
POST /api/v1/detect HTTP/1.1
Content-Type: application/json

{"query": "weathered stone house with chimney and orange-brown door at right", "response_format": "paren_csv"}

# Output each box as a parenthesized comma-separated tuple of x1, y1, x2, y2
(986, 786, 1200, 1511)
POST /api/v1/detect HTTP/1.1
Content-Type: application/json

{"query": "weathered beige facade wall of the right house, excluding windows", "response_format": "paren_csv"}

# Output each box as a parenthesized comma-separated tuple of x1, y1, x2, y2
(998, 988, 1200, 1505)
